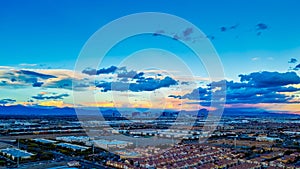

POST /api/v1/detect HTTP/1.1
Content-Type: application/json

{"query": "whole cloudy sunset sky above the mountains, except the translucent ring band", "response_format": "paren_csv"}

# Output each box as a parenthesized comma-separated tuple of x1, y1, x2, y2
(0, 0, 300, 113)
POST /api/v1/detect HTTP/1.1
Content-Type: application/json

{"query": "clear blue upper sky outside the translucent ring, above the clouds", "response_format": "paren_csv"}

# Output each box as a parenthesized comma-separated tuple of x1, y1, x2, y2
(0, 0, 300, 72)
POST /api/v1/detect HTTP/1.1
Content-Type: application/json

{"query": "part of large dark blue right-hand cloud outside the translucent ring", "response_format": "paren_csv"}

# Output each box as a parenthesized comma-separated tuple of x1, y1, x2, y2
(226, 71, 300, 104)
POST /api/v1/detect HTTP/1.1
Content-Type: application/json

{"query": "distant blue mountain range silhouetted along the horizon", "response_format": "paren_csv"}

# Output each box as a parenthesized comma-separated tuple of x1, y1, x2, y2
(0, 105, 299, 117)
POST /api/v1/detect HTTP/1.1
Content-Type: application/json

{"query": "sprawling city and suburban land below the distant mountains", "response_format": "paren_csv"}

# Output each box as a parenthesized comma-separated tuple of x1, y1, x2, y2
(0, 111, 300, 169)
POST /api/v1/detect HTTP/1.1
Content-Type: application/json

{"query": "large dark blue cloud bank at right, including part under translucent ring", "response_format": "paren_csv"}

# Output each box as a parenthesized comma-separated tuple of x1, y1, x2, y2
(182, 72, 300, 106)
